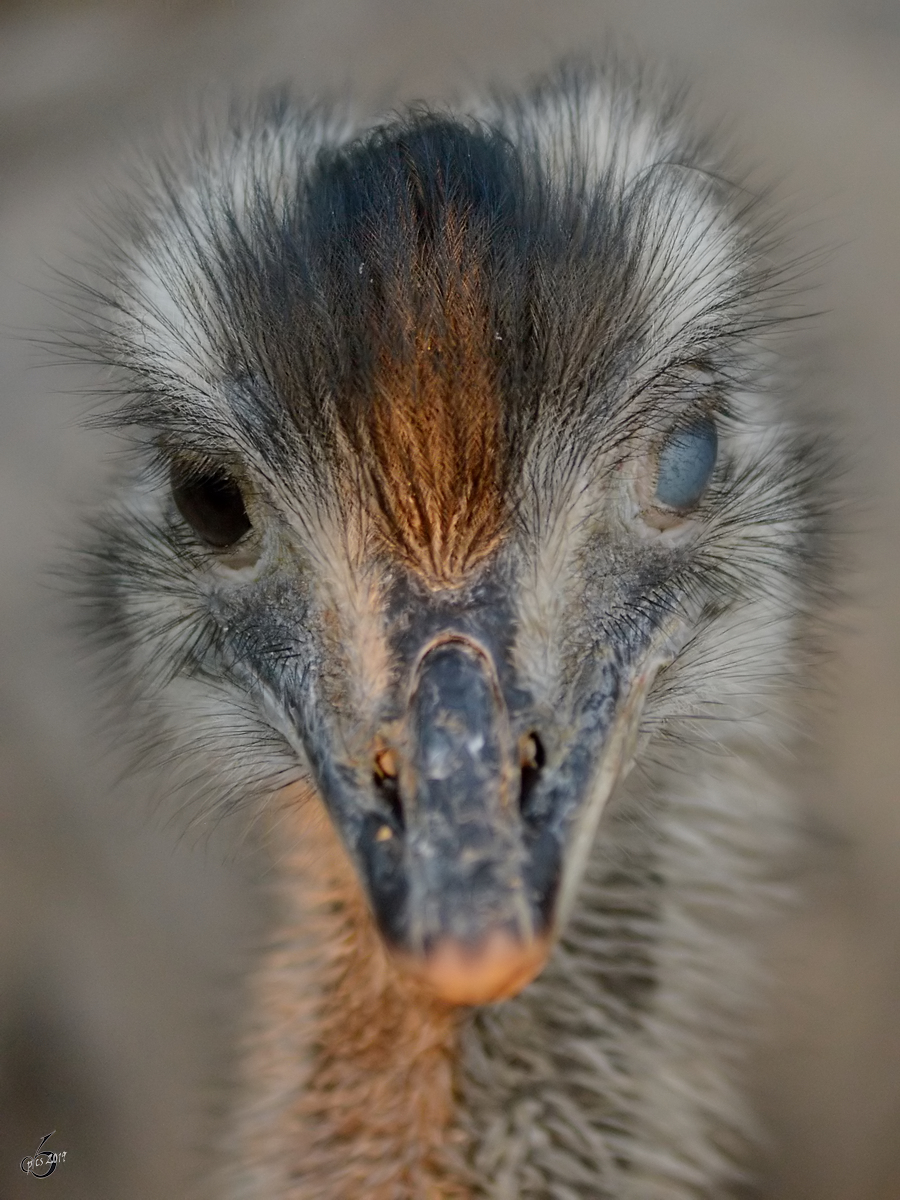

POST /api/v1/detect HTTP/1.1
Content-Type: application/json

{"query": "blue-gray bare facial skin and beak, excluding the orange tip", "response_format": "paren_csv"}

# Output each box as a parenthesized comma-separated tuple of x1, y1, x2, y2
(204, 549, 666, 998)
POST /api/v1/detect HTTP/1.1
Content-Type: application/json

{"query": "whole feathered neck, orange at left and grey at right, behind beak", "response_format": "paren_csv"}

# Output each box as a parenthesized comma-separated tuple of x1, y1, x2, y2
(221, 756, 785, 1200)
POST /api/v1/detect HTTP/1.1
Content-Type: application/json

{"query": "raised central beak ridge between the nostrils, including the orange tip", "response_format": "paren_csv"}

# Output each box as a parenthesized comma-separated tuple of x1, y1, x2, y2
(400, 637, 548, 1004)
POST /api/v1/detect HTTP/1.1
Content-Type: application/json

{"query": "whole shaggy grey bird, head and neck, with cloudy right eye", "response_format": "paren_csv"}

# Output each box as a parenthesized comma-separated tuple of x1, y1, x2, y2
(81, 67, 821, 1200)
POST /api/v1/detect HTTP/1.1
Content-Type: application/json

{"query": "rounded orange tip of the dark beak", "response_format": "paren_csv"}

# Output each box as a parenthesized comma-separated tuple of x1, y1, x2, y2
(407, 930, 550, 1007)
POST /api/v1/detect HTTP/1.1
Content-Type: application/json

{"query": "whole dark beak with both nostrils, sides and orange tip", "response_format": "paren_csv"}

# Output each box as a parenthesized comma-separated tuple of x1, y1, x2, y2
(309, 614, 667, 1004)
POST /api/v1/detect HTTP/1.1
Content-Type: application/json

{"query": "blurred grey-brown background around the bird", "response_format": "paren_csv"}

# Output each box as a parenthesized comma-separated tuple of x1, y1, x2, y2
(0, 0, 900, 1200)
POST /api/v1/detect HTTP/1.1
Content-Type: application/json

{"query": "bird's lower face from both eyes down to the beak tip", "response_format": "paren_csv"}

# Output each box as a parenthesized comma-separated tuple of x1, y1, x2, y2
(162, 410, 696, 1003)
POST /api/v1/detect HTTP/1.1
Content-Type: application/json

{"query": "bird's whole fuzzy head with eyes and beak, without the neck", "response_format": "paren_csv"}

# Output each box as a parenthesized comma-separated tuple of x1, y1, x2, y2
(86, 88, 816, 1004)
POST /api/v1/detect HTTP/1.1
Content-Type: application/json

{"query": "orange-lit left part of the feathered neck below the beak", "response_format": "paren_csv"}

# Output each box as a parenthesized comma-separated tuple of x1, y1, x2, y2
(228, 791, 468, 1200)
